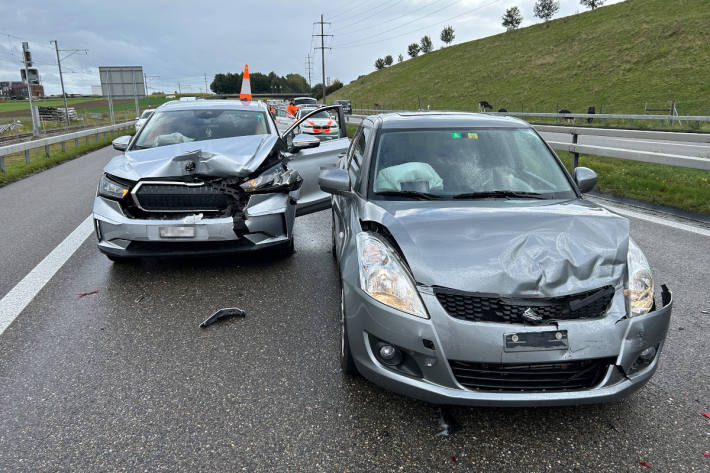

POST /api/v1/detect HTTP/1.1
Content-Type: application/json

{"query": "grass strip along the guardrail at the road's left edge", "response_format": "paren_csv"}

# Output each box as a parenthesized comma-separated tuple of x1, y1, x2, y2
(0, 133, 132, 187)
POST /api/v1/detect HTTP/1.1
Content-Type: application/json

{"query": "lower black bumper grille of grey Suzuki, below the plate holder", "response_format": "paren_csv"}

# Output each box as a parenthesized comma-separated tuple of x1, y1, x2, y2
(449, 358, 614, 392)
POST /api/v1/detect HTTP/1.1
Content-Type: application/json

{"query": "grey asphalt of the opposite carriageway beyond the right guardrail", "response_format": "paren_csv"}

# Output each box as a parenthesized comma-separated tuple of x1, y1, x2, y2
(348, 117, 710, 159)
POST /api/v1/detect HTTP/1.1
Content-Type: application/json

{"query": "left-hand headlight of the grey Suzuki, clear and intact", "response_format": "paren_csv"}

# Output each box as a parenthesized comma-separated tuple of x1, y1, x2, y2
(357, 232, 429, 319)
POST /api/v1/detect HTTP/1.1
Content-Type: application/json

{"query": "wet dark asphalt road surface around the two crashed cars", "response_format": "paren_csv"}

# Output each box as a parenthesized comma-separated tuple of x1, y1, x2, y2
(0, 149, 710, 472)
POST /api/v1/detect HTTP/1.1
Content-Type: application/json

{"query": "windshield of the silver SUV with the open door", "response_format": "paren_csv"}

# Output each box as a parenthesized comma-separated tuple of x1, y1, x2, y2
(133, 109, 268, 149)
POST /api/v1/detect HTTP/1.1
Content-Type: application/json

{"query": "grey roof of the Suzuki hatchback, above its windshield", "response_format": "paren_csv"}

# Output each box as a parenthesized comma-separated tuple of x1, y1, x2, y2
(368, 111, 530, 129)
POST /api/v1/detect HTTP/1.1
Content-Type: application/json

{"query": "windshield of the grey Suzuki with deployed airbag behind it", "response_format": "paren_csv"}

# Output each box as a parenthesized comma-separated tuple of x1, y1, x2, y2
(371, 128, 575, 199)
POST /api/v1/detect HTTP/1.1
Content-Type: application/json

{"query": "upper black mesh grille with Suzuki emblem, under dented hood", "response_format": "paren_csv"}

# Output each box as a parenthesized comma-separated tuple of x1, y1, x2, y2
(434, 286, 614, 323)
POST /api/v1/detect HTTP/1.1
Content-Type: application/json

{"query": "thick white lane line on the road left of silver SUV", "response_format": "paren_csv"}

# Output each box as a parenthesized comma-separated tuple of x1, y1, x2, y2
(0, 215, 94, 335)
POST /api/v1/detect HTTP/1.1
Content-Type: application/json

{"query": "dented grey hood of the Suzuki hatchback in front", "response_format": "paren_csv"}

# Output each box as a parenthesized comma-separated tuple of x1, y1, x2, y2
(371, 200, 629, 297)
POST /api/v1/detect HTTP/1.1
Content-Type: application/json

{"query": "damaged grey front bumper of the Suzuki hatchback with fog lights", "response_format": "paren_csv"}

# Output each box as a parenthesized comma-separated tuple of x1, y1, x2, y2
(344, 281, 673, 406)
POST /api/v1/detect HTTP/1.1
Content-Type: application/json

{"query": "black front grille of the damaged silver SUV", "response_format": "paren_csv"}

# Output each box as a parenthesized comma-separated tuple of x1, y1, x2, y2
(135, 183, 232, 212)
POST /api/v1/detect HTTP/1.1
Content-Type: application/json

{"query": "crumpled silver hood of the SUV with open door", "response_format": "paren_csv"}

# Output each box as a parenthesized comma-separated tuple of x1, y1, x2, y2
(104, 135, 278, 181)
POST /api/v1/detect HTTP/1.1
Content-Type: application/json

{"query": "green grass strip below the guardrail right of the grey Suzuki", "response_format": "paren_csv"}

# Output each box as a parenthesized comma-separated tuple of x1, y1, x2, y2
(557, 151, 710, 215)
